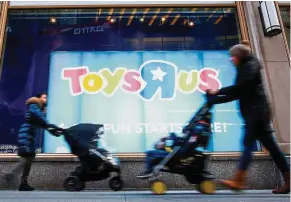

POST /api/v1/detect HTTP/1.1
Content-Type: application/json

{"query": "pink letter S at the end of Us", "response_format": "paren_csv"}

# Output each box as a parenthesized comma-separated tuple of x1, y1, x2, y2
(199, 68, 221, 92)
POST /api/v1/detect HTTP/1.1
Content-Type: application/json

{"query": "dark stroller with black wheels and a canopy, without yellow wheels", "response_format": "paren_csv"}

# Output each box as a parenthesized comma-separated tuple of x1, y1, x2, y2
(58, 124, 124, 191)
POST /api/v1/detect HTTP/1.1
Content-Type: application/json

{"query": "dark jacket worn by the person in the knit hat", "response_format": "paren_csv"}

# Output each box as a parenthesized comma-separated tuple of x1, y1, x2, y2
(214, 55, 270, 122)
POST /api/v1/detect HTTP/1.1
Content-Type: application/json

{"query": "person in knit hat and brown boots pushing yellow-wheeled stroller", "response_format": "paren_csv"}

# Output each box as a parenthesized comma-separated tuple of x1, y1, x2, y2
(208, 41, 290, 194)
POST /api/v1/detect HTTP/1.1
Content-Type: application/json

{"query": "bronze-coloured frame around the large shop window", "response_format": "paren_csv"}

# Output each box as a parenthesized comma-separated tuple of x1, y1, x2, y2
(0, 1, 267, 160)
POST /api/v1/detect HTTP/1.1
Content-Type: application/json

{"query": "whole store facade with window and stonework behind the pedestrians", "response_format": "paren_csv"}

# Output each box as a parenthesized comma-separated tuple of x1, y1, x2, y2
(0, 1, 290, 189)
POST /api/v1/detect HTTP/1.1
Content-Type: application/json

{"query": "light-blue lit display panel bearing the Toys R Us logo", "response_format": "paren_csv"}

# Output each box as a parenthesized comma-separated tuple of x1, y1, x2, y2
(44, 51, 243, 153)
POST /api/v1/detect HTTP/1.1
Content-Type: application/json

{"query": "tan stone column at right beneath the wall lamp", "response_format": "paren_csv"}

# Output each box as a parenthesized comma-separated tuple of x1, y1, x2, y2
(243, 1, 290, 154)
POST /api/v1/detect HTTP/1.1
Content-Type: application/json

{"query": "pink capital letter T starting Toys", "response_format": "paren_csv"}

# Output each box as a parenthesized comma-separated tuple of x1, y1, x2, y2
(62, 67, 89, 95)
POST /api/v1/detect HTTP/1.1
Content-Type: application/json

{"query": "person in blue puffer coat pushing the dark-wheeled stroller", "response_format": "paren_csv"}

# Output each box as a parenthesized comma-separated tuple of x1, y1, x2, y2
(4, 93, 61, 191)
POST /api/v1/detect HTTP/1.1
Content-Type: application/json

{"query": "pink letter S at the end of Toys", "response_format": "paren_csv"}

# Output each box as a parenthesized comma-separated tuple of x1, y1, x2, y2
(122, 71, 141, 92)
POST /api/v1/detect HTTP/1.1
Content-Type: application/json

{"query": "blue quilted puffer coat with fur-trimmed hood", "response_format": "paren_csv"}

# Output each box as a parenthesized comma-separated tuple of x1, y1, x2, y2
(18, 97, 54, 157)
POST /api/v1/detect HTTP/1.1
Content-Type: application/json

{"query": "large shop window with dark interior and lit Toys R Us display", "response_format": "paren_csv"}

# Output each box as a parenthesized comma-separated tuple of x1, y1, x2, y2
(0, 8, 262, 153)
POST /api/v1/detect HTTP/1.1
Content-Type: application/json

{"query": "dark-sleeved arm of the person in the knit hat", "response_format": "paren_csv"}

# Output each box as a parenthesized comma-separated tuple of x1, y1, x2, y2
(218, 61, 260, 97)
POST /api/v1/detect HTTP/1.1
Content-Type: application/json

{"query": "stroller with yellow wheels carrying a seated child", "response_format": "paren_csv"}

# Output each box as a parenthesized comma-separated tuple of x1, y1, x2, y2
(139, 95, 216, 194)
